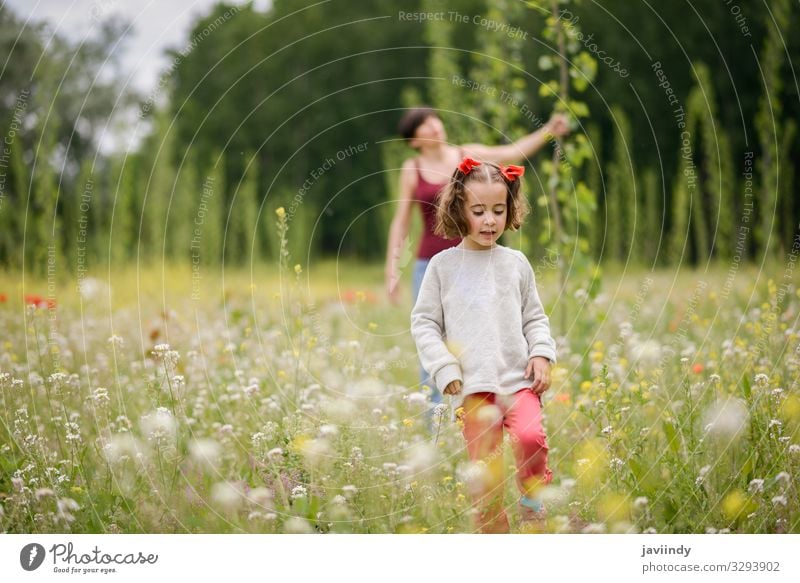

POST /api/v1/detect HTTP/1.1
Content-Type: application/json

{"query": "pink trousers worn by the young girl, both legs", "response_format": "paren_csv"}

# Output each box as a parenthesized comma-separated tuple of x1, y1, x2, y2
(463, 388, 553, 533)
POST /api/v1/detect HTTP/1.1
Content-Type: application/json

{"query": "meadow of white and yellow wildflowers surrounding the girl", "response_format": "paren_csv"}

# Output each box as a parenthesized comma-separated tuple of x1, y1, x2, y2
(0, 226, 800, 533)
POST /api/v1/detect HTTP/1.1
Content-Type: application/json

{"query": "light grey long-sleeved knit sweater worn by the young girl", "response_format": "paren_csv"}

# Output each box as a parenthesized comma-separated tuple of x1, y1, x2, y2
(411, 242, 556, 406)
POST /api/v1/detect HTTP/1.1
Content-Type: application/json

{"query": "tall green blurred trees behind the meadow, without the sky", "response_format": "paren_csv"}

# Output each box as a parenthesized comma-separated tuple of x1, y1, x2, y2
(0, 0, 800, 274)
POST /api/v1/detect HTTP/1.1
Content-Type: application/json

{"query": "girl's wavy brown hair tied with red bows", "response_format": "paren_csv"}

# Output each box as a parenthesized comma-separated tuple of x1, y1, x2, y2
(433, 162, 531, 239)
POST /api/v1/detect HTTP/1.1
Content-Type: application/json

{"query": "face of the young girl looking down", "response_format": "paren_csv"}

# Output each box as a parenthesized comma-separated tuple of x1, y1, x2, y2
(464, 182, 508, 251)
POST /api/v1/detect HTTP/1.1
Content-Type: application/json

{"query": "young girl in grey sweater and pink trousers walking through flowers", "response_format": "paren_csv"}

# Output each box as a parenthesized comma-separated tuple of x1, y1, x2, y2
(411, 158, 556, 532)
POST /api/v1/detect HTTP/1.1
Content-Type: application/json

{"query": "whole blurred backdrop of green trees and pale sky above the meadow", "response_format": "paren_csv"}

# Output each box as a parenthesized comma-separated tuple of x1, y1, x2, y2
(0, 0, 800, 276)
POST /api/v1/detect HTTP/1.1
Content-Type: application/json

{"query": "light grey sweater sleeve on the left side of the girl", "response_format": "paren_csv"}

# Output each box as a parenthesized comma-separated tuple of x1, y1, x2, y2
(411, 261, 464, 391)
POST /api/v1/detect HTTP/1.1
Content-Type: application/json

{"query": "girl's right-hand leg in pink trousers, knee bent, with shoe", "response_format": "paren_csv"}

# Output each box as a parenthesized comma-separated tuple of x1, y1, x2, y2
(505, 389, 553, 511)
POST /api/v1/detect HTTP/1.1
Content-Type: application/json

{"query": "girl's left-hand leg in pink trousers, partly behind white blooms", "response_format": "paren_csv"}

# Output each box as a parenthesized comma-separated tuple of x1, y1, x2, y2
(463, 393, 509, 533)
